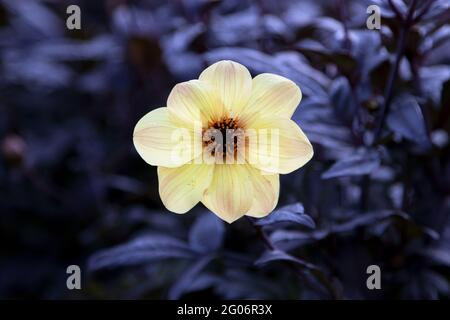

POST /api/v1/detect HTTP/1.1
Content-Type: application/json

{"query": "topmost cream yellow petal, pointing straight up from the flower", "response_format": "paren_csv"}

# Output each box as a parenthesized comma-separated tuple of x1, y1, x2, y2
(199, 60, 252, 116)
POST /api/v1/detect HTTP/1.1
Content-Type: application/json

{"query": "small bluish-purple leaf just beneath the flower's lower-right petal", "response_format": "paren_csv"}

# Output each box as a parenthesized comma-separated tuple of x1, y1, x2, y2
(255, 202, 316, 229)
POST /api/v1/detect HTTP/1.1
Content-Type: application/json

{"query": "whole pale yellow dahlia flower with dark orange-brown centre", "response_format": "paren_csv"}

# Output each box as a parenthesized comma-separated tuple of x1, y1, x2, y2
(133, 61, 313, 223)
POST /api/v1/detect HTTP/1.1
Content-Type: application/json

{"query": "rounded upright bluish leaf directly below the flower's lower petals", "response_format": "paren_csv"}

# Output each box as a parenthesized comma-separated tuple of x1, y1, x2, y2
(189, 213, 225, 253)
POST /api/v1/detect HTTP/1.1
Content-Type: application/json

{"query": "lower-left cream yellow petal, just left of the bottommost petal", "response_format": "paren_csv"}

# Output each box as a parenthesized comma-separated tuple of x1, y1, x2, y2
(158, 164, 214, 213)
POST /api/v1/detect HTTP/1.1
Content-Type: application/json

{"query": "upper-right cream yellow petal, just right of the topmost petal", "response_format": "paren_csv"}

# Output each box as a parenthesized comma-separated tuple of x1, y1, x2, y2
(241, 73, 302, 123)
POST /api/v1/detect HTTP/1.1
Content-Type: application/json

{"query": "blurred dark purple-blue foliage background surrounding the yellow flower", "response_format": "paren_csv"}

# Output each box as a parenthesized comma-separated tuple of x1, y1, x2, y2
(0, 0, 450, 299)
